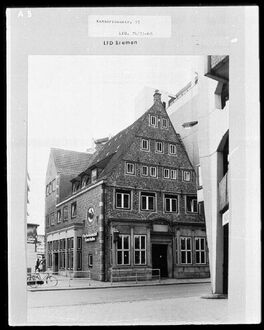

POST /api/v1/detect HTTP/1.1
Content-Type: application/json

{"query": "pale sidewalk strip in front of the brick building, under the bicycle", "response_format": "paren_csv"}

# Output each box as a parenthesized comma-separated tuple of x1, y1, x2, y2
(28, 276, 210, 291)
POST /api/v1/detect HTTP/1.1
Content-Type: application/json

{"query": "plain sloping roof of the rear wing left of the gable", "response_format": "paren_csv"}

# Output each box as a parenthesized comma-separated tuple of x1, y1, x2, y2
(51, 148, 93, 175)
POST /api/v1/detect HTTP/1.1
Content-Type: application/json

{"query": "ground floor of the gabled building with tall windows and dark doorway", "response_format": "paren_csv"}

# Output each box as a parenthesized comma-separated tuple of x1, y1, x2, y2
(47, 220, 209, 281)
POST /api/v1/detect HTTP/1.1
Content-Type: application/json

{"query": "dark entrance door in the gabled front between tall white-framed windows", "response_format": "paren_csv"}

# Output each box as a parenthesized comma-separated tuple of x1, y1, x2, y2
(152, 244, 168, 277)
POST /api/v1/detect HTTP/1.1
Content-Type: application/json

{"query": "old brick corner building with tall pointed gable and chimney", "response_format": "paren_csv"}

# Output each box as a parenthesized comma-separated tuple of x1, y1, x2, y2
(47, 91, 209, 280)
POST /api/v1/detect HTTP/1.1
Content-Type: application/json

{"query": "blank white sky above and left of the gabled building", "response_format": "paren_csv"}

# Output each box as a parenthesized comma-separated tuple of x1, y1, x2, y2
(28, 55, 200, 234)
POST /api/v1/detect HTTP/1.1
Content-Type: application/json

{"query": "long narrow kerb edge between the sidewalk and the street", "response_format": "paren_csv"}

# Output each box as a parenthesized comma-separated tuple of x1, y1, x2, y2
(28, 280, 211, 292)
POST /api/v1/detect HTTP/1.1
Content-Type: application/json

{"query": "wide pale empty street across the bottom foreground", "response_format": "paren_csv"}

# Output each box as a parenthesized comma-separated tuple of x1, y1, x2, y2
(28, 283, 228, 325)
